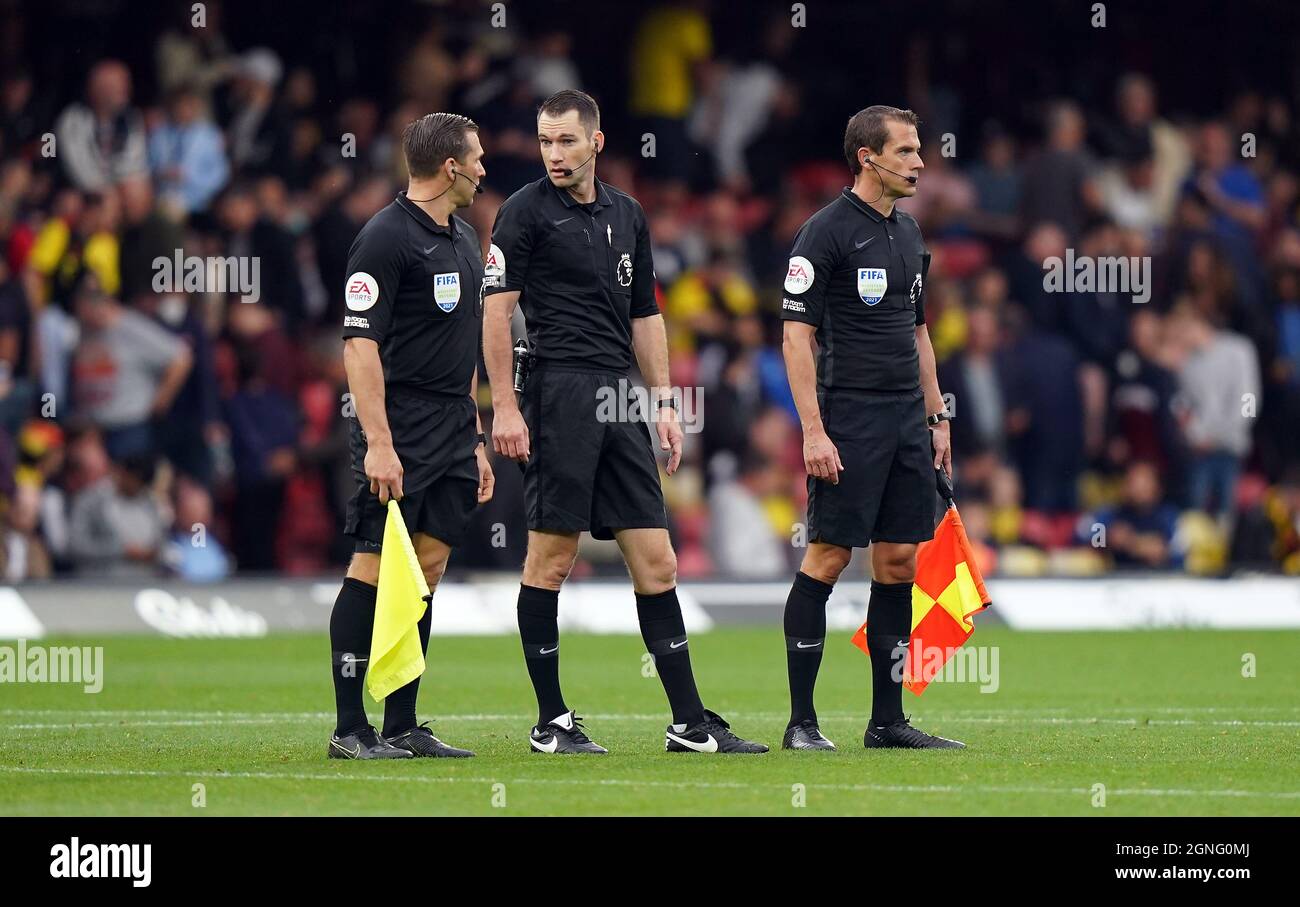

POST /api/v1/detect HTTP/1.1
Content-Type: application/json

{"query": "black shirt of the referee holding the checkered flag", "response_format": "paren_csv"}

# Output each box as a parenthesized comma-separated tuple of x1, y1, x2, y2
(781, 188, 930, 391)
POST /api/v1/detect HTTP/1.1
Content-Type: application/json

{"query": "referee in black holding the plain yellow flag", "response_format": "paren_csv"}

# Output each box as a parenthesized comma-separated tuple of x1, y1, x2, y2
(329, 113, 493, 759)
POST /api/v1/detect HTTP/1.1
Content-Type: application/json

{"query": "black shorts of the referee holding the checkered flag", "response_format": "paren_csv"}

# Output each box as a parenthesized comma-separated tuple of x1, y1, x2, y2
(809, 389, 937, 548)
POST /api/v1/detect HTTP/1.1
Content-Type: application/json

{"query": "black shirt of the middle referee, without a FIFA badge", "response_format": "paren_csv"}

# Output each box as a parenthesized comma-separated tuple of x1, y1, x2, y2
(484, 177, 659, 373)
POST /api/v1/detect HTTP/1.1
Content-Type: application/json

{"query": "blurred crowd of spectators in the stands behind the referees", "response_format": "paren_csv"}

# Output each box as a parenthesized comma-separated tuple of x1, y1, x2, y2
(0, 3, 1300, 582)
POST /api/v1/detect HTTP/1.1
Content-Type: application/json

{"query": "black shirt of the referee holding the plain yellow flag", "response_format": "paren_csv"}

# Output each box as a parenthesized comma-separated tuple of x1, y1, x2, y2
(343, 194, 484, 394)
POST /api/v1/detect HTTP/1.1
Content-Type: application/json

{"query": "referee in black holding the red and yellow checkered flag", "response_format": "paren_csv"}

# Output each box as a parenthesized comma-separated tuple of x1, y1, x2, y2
(781, 105, 963, 750)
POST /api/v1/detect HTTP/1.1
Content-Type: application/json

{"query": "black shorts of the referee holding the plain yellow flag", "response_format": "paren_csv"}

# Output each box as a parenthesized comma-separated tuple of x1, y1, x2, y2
(343, 387, 478, 554)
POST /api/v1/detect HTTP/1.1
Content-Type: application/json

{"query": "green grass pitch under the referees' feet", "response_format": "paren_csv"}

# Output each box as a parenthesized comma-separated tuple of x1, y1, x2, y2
(0, 628, 1300, 816)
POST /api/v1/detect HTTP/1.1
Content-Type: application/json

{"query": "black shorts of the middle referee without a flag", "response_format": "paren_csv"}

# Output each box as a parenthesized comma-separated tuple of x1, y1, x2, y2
(523, 365, 668, 539)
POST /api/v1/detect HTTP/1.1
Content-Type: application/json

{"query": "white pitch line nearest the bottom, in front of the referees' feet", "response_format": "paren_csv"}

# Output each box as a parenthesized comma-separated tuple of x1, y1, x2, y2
(0, 765, 1300, 799)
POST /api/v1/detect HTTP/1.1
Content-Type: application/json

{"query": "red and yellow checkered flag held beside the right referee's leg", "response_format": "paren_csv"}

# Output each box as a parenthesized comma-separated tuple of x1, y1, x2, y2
(853, 505, 989, 696)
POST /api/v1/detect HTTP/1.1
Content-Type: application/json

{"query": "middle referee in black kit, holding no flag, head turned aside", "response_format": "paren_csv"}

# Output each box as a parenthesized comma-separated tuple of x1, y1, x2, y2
(484, 91, 767, 754)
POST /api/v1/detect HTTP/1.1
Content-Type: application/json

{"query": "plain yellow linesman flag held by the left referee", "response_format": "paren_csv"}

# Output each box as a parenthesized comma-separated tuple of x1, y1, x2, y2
(365, 500, 432, 702)
